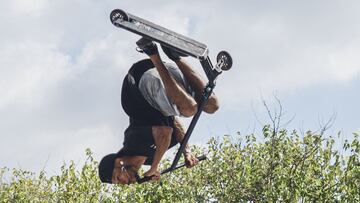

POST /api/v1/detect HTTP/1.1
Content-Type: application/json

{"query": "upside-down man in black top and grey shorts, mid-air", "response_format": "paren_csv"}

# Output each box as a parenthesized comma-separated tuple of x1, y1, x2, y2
(99, 38, 219, 184)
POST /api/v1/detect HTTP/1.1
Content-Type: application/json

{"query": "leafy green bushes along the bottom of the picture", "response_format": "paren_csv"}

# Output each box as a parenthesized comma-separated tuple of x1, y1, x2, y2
(0, 126, 360, 202)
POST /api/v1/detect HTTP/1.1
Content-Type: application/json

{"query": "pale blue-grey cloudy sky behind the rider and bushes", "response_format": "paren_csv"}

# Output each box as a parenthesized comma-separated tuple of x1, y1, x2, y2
(0, 0, 360, 173)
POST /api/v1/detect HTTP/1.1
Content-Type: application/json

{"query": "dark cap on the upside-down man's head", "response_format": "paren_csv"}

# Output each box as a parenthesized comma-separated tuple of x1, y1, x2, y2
(99, 153, 117, 183)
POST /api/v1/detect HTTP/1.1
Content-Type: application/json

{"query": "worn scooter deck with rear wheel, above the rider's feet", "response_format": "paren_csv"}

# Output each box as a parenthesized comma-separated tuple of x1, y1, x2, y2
(110, 9, 209, 60)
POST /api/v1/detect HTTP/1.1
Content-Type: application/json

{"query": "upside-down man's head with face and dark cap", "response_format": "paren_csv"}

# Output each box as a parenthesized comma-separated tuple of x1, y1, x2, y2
(99, 153, 136, 184)
